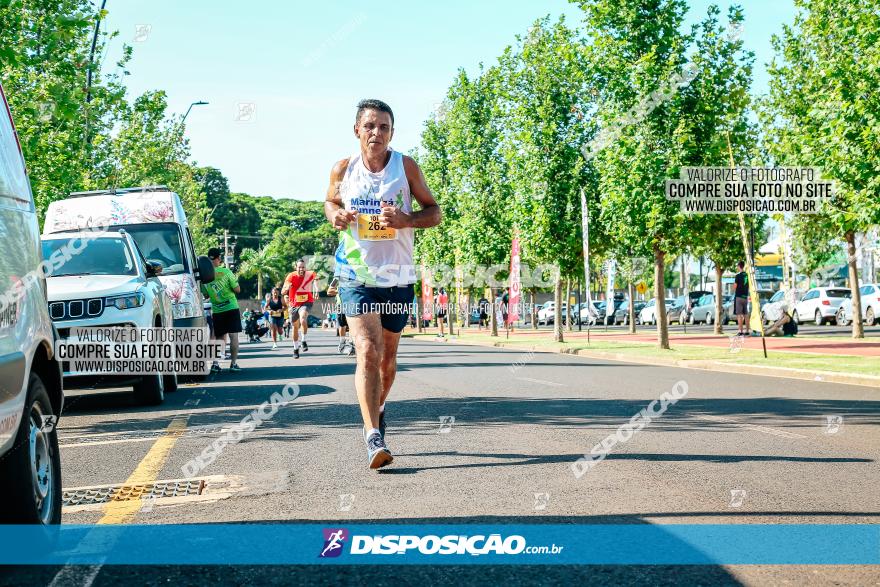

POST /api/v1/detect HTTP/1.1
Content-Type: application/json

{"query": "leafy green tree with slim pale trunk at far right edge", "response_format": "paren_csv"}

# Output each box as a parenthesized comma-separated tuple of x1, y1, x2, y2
(763, 0, 880, 338)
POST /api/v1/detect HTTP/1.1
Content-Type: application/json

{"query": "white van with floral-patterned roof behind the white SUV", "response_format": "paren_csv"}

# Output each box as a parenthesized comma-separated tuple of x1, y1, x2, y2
(43, 186, 214, 327)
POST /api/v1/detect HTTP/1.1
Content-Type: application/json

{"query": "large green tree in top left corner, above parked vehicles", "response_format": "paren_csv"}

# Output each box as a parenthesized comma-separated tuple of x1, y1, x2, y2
(0, 0, 131, 215)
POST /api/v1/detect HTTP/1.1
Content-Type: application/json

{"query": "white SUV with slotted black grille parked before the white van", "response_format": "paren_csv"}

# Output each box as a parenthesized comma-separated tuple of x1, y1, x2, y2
(43, 230, 176, 405)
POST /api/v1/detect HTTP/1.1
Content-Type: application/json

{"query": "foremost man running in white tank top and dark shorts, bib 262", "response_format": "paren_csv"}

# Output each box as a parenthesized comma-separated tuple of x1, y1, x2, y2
(324, 100, 441, 469)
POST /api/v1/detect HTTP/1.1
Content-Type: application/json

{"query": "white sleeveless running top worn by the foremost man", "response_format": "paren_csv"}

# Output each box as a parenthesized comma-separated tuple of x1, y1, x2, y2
(336, 149, 416, 287)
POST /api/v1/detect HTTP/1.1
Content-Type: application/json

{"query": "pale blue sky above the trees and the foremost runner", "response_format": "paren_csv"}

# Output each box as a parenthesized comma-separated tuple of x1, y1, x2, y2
(104, 0, 794, 200)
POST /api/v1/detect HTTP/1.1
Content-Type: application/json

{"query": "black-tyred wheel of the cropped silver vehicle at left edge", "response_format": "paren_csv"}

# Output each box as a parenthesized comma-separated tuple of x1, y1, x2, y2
(0, 373, 61, 525)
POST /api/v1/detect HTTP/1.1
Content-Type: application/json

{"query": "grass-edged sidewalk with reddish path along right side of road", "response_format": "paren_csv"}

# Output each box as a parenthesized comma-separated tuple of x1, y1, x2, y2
(405, 327, 880, 389)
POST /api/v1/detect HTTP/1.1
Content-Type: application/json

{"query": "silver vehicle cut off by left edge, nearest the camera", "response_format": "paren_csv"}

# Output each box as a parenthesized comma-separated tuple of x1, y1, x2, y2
(0, 81, 64, 524)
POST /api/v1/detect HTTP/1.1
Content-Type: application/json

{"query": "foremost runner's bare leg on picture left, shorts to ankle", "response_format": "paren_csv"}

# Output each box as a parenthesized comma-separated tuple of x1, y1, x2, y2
(347, 314, 385, 430)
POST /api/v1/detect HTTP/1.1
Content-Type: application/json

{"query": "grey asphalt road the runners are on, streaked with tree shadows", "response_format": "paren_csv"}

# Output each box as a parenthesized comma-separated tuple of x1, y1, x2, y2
(0, 327, 880, 585)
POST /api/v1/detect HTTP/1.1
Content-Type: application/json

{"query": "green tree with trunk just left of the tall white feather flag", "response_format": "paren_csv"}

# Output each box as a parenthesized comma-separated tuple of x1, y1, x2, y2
(498, 17, 595, 342)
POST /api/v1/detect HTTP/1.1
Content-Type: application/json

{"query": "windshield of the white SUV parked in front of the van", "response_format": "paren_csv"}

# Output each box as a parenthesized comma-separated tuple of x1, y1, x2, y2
(43, 238, 138, 277)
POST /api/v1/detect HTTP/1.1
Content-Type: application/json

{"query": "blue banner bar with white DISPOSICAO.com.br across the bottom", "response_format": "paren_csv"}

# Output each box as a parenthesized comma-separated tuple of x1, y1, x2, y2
(0, 522, 880, 565)
